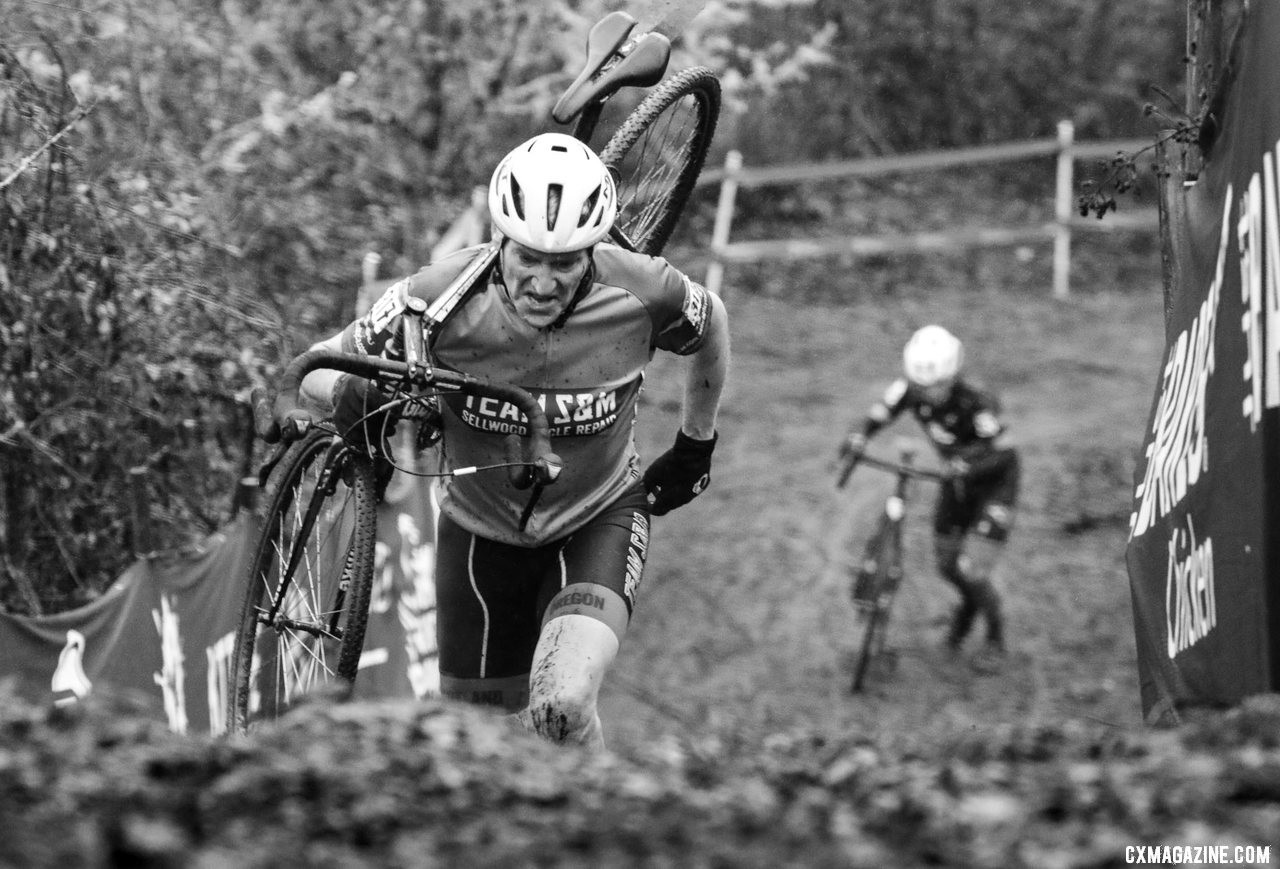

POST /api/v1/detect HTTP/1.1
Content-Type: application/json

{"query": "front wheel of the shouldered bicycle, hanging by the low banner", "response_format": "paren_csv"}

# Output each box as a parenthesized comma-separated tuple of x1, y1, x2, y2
(227, 430, 376, 732)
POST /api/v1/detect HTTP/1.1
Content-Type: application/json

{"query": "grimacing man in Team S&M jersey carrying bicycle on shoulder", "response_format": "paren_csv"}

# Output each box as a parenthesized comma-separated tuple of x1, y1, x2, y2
(294, 133, 730, 749)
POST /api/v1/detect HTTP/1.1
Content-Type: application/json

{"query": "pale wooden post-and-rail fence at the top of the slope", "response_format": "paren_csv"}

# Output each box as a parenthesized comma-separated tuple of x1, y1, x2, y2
(698, 120, 1158, 298)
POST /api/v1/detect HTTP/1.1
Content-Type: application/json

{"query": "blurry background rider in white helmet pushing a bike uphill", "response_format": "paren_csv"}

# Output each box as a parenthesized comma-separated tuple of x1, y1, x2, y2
(840, 325, 1020, 669)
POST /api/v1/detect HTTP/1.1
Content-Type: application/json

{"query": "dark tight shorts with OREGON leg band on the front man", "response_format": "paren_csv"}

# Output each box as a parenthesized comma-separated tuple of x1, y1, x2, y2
(435, 482, 649, 710)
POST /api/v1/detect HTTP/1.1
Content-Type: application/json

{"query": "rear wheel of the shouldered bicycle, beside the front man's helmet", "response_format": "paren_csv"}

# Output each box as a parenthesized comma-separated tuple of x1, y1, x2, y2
(600, 67, 721, 255)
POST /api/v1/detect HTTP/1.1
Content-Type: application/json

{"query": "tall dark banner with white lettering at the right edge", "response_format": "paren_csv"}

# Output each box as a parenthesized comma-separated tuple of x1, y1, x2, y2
(1126, 0, 1280, 721)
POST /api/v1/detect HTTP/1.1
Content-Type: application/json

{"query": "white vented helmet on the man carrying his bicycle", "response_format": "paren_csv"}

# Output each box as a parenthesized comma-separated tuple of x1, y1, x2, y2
(489, 133, 618, 253)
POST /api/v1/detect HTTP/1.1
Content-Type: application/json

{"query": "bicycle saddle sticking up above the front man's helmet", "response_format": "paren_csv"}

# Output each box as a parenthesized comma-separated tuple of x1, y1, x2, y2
(552, 12, 671, 124)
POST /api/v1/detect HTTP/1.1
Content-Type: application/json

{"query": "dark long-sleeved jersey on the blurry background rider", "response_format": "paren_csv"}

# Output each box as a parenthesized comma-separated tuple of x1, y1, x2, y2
(864, 378, 1005, 461)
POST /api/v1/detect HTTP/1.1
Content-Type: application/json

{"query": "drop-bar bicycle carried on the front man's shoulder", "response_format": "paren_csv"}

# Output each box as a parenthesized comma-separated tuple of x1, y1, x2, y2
(227, 13, 719, 733)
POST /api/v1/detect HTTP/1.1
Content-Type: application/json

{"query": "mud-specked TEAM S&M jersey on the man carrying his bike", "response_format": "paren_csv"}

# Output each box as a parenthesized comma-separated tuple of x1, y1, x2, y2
(342, 243, 710, 546)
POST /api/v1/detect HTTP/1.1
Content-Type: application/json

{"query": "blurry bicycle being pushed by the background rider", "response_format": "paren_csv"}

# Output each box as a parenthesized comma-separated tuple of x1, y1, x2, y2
(836, 447, 947, 694)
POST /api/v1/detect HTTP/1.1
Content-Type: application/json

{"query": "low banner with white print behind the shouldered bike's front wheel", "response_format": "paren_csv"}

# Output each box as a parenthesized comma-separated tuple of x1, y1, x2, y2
(0, 475, 439, 733)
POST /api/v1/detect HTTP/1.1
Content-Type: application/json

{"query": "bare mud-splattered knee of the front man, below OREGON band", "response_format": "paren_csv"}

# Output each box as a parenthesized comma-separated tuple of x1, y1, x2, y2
(518, 614, 618, 751)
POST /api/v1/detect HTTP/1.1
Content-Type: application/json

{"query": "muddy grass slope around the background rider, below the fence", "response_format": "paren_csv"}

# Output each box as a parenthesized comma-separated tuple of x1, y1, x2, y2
(603, 276, 1164, 751)
